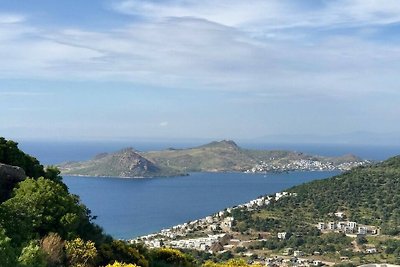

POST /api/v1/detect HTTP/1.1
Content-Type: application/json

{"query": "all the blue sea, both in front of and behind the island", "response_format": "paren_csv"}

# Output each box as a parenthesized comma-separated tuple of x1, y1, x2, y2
(19, 141, 400, 239)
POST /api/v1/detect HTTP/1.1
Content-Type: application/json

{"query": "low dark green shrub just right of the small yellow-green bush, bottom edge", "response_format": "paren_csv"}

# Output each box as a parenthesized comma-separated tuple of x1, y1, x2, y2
(98, 240, 149, 267)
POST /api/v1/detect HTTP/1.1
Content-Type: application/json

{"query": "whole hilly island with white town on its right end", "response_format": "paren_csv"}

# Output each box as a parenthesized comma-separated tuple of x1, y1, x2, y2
(58, 140, 370, 178)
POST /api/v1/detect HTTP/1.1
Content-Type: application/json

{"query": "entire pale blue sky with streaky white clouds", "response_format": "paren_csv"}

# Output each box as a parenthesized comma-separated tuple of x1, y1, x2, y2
(0, 0, 400, 144)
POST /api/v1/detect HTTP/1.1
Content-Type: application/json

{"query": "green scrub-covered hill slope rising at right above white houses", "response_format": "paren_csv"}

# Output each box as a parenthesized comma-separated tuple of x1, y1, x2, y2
(268, 157, 400, 234)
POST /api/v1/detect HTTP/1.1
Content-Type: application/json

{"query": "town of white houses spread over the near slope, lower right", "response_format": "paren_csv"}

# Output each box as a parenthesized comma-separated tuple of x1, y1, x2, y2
(129, 192, 380, 266)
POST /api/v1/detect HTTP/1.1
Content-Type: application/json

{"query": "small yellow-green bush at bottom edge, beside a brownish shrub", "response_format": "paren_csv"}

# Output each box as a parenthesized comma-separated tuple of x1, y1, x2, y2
(65, 238, 97, 267)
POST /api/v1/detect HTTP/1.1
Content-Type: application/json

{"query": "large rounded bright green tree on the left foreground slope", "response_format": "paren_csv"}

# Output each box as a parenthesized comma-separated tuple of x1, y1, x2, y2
(0, 177, 91, 244)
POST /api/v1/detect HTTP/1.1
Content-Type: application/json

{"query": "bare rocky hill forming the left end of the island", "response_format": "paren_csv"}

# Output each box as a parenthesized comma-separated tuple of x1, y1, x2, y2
(60, 148, 182, 178)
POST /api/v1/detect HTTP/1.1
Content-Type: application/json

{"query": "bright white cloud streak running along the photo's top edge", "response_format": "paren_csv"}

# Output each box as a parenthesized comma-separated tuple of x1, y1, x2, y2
(114, 0, 400, 30)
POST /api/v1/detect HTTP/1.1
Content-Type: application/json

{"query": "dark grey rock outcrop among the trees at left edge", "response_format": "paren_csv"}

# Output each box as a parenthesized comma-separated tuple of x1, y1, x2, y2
(0, 163, 26, 203)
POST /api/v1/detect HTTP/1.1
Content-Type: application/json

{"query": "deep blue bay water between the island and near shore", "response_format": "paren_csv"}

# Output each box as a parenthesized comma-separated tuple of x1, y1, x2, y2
(64, 171, 339, 239)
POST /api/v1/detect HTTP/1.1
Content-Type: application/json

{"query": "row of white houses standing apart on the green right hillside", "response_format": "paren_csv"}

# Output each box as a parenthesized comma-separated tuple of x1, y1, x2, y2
(317, 221, 380, 235)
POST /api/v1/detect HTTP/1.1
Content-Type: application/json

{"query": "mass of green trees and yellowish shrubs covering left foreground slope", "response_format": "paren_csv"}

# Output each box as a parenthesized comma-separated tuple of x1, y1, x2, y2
(0, 138, 196, 267)
